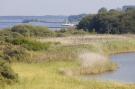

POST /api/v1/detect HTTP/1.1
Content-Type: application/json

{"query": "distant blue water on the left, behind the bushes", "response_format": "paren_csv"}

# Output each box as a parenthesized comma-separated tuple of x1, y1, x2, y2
(0, 16, 67, 30)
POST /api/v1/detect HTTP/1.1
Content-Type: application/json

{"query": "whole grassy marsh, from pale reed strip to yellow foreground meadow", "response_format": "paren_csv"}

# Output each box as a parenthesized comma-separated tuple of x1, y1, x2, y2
(2, 35, 135, 89)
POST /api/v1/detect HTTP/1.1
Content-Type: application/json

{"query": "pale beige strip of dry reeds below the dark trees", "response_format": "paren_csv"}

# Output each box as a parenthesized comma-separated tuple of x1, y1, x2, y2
(37, 35, 133, 45)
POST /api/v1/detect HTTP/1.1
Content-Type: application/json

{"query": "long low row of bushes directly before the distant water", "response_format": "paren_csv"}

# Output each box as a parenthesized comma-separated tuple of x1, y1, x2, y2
(0, 25, 88, 37)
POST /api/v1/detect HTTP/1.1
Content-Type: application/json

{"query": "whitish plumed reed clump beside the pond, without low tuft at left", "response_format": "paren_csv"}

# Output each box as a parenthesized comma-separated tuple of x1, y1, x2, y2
(79, 52, 117, 74)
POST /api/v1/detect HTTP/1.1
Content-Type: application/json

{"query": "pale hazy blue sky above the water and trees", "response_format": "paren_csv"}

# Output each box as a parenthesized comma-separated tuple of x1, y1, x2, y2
(0, 0, 135, 16)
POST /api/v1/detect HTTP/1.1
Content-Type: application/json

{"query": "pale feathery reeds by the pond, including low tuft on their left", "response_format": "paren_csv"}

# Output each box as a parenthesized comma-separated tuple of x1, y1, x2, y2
(60, 52, 117, 76)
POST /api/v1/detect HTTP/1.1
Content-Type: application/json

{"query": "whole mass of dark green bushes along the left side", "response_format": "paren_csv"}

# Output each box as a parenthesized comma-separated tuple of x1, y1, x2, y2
(0, 25, 57, 85)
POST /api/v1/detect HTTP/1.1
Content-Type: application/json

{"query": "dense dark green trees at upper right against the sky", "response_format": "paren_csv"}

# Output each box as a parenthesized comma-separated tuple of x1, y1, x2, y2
(77, 8, 135, 34)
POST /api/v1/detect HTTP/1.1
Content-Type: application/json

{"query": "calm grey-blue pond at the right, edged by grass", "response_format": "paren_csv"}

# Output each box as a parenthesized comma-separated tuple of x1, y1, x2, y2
(85, 53, 135, 83)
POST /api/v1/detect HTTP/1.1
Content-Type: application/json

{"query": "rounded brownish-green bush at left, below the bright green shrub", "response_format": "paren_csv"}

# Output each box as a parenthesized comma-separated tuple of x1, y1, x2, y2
(2, 46, 30, 62)
